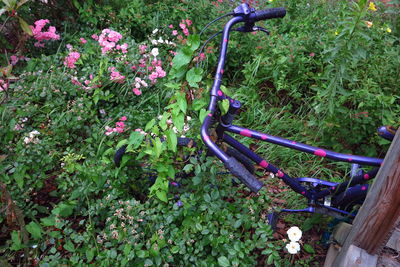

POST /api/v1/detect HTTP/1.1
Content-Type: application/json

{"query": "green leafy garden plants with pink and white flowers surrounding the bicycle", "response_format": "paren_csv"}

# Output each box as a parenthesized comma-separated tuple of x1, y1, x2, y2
(0, 0, 400, 266)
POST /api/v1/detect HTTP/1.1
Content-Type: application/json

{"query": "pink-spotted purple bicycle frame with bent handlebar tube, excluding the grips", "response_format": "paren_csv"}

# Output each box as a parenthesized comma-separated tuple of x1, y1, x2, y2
(201, 9, 383, 219)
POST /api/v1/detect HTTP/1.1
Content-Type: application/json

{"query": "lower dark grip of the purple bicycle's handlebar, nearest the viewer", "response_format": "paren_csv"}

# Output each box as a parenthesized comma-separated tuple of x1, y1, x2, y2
(224, 157, 263, 193)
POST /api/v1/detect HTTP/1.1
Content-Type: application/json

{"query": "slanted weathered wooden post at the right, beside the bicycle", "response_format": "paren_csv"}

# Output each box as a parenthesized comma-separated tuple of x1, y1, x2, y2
(333, 129, 400, 267)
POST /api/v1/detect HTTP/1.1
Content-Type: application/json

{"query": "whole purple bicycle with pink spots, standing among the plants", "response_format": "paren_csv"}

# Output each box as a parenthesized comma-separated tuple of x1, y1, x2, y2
(201, 3, 395, 222)
